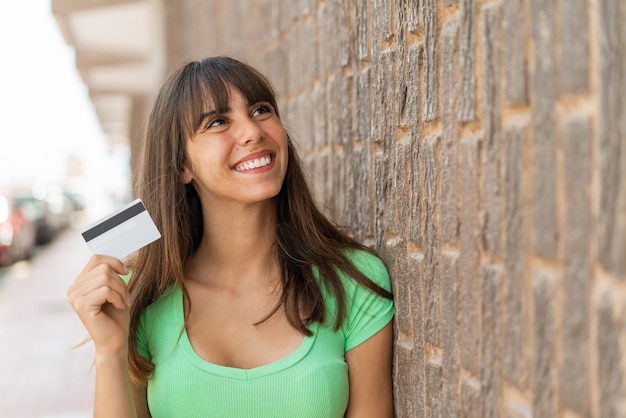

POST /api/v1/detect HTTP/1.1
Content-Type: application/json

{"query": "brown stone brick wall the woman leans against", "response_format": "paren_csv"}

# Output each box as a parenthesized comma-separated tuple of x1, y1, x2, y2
(164, 0, 626, 418)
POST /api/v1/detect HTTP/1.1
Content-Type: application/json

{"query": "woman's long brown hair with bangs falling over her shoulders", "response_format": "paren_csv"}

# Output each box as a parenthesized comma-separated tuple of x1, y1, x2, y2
(129, 57, 391, 383)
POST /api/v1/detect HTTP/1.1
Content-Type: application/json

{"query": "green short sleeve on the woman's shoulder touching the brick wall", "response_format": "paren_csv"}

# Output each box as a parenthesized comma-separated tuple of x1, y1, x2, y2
(342, 251, 394, 351)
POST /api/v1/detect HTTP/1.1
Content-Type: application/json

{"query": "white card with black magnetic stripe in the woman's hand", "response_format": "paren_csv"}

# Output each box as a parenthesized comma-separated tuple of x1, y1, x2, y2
(81, 199, 161, 259)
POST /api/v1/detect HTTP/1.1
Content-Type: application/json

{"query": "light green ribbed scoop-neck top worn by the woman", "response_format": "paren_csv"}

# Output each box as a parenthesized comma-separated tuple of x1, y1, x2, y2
(137, 251, 394, 418)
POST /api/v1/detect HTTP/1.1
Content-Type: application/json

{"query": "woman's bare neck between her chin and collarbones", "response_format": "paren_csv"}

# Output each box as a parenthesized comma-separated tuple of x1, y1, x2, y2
(186, 204, 278, 287)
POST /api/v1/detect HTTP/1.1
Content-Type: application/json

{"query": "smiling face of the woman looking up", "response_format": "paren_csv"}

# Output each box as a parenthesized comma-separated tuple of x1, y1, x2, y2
(182, 86, 288, 207)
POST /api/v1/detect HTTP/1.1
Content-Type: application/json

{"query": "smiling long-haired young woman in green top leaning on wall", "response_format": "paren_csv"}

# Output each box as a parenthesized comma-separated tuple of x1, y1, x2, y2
(68, 57, 394, 418)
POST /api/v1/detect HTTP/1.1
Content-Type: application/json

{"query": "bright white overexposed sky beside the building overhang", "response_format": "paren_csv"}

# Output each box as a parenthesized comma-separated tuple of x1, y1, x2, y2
(0, 0, 127, 202)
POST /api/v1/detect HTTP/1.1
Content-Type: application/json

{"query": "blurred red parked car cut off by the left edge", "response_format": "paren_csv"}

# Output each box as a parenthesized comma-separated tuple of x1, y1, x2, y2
(0, 193, 36, 266)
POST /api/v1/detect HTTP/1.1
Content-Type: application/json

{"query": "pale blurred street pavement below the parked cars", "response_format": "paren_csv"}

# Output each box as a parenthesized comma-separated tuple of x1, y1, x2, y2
(0, 217, 94, 418)
